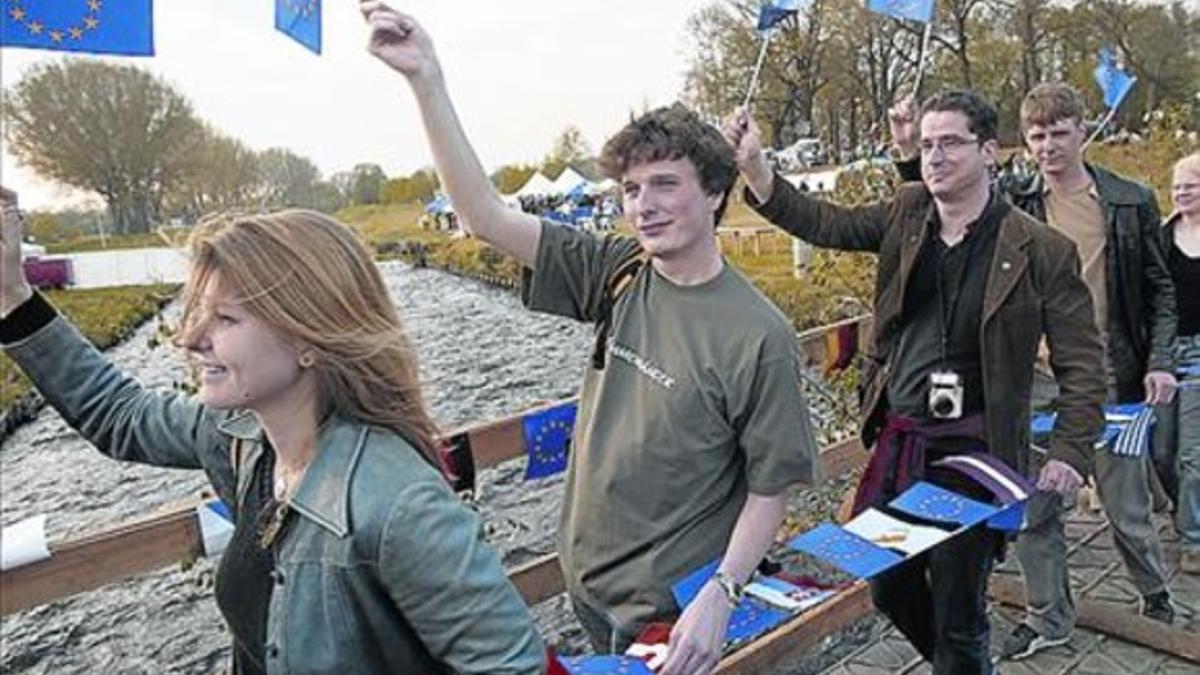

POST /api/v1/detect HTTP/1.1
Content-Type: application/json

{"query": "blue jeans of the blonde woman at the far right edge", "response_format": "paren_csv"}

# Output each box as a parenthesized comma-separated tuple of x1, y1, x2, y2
(1154, 335, 1200, 550)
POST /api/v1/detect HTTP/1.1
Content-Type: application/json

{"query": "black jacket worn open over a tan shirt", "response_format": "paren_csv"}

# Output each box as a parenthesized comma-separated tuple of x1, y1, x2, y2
(896, 159, 1177, 402)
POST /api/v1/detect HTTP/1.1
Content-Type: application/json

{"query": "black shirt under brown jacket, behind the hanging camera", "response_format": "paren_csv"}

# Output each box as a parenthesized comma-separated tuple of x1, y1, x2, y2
(888, 192, 1012, 419)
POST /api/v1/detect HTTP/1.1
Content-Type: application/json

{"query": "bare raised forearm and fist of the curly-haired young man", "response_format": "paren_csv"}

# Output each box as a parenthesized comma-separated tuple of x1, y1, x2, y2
(361, 0, 541, 267)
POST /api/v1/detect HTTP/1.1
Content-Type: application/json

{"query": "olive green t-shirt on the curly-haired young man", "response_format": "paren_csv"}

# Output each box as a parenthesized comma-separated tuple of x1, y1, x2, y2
(524, 223, 817, 633)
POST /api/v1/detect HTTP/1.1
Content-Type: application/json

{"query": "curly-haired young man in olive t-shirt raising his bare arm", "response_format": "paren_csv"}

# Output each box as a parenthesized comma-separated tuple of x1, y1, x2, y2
(362, 1, 816, 675)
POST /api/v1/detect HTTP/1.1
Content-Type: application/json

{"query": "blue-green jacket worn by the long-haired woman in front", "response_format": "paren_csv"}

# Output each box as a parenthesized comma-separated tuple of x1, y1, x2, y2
(5, 316, 544, 675)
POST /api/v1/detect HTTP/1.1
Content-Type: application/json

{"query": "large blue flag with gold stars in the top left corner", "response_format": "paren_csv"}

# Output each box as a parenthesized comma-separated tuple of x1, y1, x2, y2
(0, 0, 154, 56)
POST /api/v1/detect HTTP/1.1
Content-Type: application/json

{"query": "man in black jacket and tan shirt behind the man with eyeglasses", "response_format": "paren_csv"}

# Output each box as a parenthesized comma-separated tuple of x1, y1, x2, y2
(896, 78, 1176, 659)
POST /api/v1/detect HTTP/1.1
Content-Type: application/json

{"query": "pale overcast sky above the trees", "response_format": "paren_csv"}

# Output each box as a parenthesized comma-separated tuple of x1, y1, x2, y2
(0, 0, 706, 209)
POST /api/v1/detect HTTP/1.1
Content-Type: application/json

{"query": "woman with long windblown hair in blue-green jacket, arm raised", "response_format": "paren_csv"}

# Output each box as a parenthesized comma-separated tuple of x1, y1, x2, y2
(0, 189, 544, 674)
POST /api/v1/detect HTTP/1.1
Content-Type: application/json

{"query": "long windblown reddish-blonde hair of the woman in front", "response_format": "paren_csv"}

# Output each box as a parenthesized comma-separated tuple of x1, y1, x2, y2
(182, 210, 438, 466)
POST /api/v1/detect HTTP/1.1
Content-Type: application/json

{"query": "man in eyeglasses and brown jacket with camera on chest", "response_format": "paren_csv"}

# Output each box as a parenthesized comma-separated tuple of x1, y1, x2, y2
(725, 90, 1104, 674)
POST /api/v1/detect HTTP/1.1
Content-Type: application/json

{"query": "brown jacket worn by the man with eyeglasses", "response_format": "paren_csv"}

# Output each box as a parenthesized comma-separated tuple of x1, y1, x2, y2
(746, 175, 1105, 476)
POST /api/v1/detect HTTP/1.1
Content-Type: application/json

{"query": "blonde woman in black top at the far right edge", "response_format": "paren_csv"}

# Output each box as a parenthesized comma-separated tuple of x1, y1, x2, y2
(1156, 153, 1200, 574)
